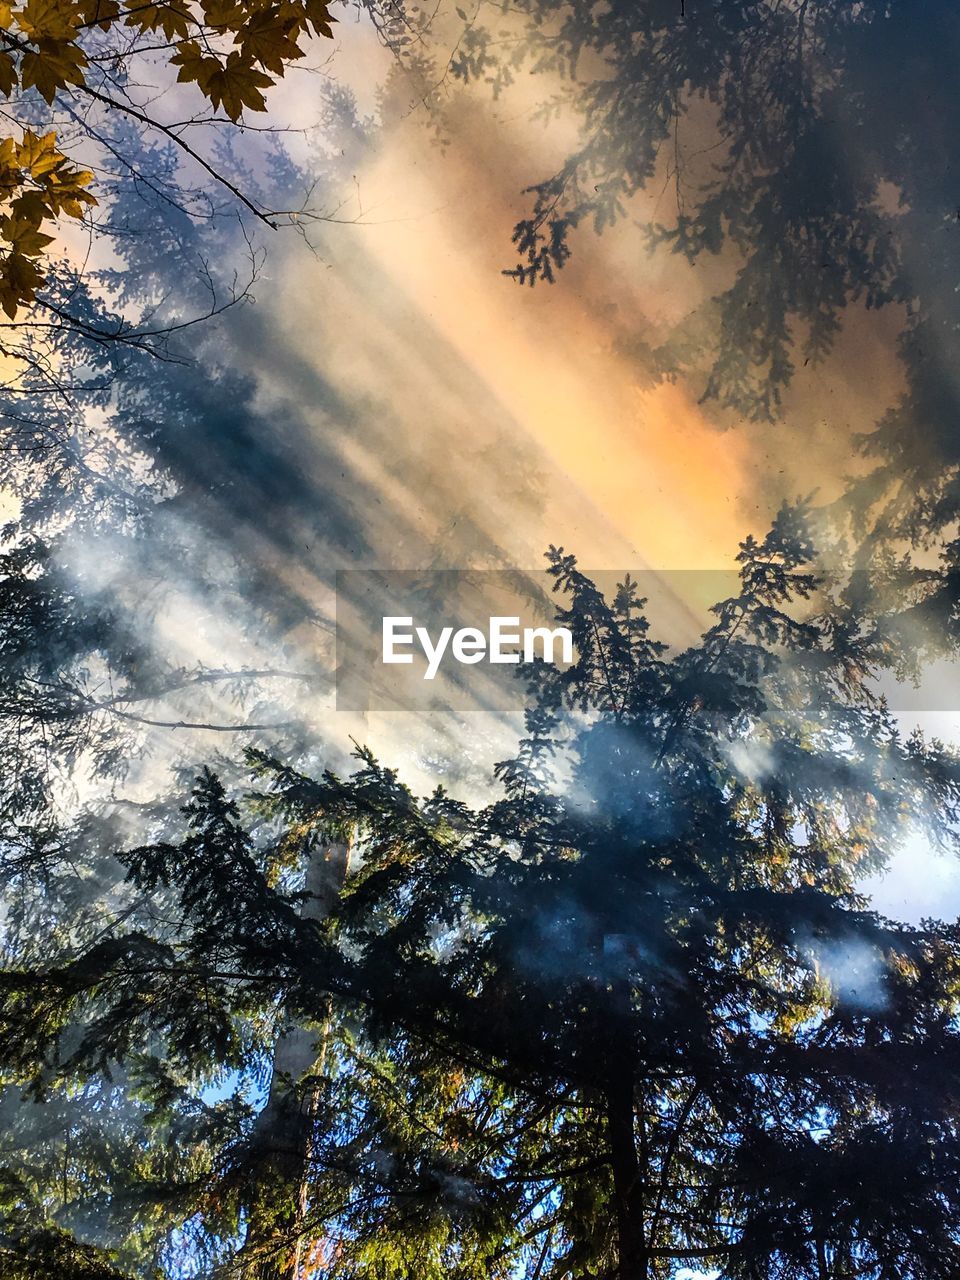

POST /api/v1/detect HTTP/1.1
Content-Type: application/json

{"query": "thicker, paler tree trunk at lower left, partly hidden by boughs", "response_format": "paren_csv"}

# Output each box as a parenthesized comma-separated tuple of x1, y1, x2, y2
(239, 841, 349, 1280)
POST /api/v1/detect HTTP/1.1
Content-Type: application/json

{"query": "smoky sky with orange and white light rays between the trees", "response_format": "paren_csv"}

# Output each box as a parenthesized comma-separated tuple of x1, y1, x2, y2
(5, 7, 960, 1280)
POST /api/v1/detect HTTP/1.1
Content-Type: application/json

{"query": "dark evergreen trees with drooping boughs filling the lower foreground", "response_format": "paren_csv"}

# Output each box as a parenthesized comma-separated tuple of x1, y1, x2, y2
(4, 508, 960, 1280)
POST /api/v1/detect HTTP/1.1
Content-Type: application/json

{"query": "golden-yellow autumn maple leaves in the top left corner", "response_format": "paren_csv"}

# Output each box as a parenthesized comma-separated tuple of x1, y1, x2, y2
(0, 0, 334, 320)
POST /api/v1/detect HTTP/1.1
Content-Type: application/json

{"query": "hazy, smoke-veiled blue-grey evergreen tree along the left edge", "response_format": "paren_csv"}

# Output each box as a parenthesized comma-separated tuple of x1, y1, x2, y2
(0, 95, 368, 1276)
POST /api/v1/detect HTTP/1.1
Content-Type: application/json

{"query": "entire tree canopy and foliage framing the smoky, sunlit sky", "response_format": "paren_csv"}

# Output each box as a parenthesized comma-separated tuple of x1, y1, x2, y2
(0, 0, 960, 1280)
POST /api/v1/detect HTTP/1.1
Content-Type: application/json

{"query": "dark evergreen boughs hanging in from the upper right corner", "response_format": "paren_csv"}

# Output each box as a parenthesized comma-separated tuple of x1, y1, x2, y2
(452, 0, 960, 460)
